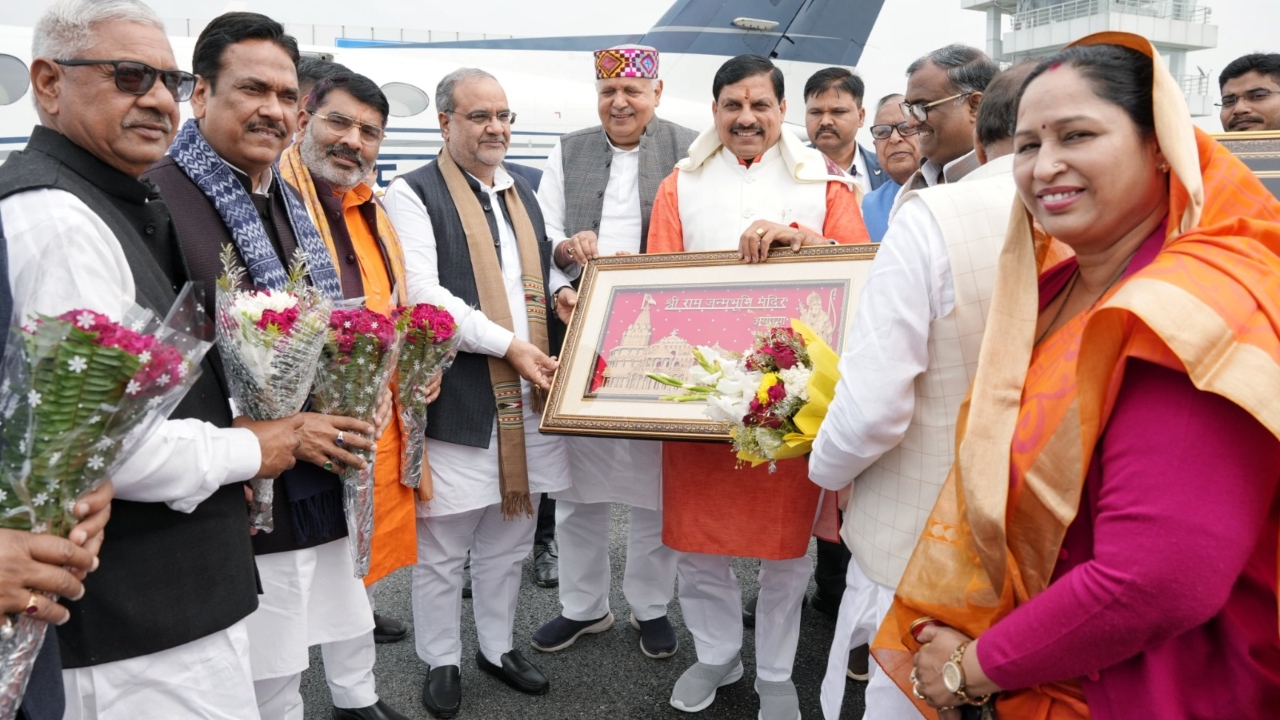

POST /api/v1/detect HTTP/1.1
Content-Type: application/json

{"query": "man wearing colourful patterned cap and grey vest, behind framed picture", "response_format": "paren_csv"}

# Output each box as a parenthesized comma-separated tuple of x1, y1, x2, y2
(532, 45, 698, 657)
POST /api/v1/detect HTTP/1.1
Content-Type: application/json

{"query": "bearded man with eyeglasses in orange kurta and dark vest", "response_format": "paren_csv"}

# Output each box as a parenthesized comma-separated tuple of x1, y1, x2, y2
(280, 74, 417, 655)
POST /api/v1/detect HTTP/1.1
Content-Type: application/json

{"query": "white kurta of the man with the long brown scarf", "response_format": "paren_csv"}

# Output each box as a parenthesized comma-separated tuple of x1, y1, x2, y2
(383, 167, 570, 518)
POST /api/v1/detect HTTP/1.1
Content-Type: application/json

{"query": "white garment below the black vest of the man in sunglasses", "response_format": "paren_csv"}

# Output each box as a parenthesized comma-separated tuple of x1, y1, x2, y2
(63, 620, 259, 720)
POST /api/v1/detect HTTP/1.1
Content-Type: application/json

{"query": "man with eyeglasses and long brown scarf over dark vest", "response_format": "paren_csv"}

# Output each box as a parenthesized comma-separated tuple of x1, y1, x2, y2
(383, 68, 570, 717)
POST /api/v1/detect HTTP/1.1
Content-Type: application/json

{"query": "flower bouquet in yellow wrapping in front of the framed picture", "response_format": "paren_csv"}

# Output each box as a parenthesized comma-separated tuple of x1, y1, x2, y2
(649, 319, 840, 473)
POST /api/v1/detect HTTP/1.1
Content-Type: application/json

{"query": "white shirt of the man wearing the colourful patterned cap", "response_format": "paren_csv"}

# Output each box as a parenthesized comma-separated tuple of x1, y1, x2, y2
(538, 136, 644, 285)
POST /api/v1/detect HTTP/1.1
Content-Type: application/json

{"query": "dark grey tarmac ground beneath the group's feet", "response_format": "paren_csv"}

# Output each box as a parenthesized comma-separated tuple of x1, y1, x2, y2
(302, 505, 867, 720)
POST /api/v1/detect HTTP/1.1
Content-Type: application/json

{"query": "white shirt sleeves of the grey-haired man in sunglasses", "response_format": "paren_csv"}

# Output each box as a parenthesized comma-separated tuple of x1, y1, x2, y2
(0, 188, 262, 512)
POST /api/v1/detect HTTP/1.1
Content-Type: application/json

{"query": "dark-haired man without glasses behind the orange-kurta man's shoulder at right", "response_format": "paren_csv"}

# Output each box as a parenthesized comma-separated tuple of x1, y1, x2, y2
(804, 68, 884, 197)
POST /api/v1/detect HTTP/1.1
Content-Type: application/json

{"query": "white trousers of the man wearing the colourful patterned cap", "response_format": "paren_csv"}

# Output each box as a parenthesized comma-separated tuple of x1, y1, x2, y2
(556, 500, 676, 620)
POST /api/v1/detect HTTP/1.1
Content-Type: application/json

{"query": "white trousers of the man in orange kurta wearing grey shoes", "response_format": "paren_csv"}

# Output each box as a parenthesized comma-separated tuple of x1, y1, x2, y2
(677, 552, 813, 683)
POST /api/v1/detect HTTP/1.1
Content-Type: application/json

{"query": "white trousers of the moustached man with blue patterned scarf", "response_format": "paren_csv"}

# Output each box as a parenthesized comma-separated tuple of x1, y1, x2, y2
(253, 633, 378, 720)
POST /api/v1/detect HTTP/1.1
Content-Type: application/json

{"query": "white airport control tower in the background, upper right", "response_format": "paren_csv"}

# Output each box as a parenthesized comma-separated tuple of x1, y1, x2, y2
(960, 0, 1217, 117)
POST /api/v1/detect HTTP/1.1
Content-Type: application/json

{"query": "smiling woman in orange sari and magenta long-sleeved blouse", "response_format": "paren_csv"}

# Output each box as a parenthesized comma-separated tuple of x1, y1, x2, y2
(873, 33, 1280, 719)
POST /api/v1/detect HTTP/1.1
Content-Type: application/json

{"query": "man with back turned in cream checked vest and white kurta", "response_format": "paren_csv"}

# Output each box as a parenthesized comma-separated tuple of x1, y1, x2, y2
(809, 61, 1036, 720)
